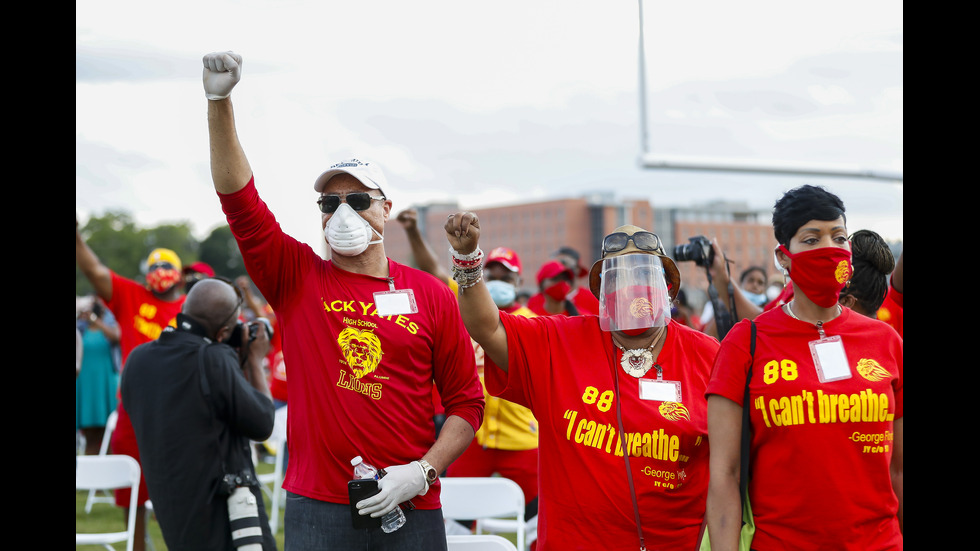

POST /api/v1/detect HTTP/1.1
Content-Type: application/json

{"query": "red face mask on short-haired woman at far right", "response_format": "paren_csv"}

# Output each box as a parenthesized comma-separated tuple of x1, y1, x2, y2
(779, 245, 852, 308)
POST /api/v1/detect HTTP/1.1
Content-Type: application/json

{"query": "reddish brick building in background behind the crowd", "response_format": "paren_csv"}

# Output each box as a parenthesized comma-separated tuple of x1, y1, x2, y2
(385, 193, 776, 307)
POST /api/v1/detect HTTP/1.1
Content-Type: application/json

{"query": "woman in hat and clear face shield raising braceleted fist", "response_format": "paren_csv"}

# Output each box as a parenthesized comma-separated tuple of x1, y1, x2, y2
(445, 212, 718, 551)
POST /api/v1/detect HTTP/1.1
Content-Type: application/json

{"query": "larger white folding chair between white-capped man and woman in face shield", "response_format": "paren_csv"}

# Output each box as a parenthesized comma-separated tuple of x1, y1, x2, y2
(439, 476, 527, 551)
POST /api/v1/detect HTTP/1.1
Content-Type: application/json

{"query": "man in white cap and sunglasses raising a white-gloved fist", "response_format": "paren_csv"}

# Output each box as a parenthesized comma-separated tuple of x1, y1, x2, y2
(203, 52, 484, 551)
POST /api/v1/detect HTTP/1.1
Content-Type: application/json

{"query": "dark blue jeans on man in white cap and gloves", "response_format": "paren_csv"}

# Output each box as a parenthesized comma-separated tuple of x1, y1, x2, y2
(283, 492, 446, 551)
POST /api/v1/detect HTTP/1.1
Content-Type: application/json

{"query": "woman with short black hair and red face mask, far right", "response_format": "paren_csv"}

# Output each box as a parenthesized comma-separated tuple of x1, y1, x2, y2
(707, 186, 904, 551)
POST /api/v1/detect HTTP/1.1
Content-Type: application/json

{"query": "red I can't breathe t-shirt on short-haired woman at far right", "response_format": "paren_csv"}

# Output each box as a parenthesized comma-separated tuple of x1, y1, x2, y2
(707, 308, 903, 550)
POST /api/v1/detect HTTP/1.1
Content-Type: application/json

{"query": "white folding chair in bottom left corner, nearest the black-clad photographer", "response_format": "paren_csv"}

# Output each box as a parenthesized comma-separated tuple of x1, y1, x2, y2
(75, 455, 140, 551)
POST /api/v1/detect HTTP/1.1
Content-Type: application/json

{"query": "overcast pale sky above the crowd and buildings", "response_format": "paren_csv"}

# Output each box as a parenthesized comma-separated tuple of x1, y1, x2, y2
(75, 0, 904, 250)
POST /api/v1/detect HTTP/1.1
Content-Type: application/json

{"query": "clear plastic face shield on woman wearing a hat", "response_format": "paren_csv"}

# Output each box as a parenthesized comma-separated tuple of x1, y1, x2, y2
(599, 254, 670, 331)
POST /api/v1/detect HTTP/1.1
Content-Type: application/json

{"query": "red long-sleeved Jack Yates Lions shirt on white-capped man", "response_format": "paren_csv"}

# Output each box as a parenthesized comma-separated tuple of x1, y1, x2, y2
(219, 181, 484, 509)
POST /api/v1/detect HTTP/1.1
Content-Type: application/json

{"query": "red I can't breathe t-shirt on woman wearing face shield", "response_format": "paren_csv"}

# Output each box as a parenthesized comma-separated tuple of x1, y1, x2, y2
(484, 314, 718, 551)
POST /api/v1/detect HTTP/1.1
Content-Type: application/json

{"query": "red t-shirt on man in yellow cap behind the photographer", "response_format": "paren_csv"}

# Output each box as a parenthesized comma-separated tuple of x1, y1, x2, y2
(106, 272, 187, 364)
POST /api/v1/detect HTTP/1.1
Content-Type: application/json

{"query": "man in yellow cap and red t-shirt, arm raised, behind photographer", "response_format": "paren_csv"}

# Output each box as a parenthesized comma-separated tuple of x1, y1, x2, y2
(75, 219, 186, 551)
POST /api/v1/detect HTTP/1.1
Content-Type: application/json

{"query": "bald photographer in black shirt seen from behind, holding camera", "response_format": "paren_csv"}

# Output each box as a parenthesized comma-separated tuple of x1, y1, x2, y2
(120, 279, 276, 551)
